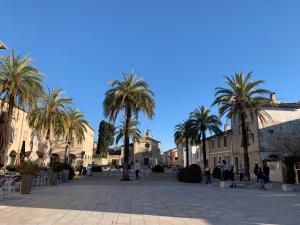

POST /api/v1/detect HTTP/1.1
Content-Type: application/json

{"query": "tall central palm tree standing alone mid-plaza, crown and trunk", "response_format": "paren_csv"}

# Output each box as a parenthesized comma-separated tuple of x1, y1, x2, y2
(103, 72, 155, 181)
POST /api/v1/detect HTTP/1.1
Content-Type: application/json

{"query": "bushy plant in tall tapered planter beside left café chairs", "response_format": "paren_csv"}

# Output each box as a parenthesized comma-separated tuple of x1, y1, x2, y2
(17, 162, 39, 194)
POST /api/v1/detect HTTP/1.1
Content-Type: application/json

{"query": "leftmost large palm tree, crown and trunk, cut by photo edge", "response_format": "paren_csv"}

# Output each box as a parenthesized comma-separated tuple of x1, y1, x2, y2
(0, 51, 44, 165)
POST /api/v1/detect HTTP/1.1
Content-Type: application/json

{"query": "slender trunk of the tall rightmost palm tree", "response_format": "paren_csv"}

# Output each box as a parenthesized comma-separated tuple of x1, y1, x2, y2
(241, 112, 250, 181)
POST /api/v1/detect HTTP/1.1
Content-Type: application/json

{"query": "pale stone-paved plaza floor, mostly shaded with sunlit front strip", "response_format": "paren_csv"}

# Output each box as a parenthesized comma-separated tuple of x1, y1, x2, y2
(0, 176, 300, 225)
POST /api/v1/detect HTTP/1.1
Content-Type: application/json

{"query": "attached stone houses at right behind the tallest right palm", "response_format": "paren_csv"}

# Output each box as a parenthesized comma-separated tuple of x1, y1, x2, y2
(206, 94, 300, 182)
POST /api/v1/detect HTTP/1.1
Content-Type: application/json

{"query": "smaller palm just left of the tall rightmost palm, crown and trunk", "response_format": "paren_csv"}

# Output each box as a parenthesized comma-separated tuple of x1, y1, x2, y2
(190, 106, 222, 168)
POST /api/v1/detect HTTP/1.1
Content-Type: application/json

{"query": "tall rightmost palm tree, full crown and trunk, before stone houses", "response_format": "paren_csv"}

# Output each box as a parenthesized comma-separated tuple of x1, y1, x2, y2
(213, 72, 271, 180)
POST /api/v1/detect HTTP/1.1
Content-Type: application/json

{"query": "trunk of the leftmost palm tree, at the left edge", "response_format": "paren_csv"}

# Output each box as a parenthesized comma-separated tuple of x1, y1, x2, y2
(1, 96, 15, 166)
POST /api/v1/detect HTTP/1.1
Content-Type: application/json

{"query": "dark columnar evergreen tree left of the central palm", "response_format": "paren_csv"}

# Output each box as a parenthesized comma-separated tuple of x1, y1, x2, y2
(96, 120, 115, 158)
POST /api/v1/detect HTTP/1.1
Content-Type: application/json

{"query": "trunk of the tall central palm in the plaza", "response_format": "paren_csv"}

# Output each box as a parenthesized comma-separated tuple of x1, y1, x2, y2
(122, 106, 131, 181)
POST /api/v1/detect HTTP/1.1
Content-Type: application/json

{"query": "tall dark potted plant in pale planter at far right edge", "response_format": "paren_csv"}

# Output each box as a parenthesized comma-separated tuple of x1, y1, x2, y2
(282, 156, 296, 192)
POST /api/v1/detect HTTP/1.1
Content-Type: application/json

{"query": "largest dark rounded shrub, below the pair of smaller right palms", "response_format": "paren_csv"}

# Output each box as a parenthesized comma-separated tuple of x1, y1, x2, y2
(177, 165, 202, 183)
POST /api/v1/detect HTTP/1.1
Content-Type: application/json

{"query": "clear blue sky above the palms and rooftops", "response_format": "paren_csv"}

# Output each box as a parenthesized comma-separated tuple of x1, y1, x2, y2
(0, 0, 300, 150)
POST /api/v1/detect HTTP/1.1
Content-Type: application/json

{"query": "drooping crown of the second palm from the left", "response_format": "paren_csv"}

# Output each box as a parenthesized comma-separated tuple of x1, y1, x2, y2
(28, 88, 72, 160)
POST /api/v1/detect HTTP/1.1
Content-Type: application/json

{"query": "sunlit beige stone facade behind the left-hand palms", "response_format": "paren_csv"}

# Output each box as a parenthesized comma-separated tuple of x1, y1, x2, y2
(0, 101, 94, 166)
